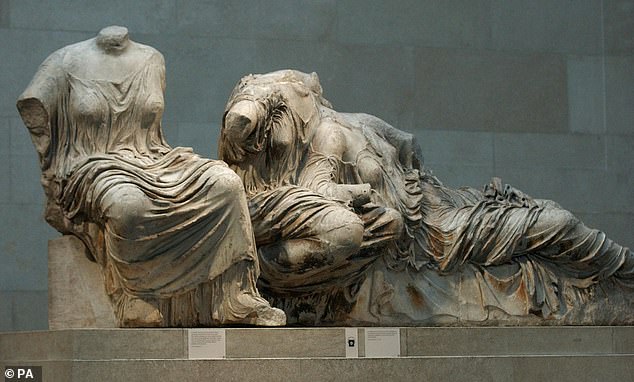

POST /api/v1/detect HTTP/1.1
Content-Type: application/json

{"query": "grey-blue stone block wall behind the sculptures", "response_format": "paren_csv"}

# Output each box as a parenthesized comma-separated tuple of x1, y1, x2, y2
(0, 0, 634, 330)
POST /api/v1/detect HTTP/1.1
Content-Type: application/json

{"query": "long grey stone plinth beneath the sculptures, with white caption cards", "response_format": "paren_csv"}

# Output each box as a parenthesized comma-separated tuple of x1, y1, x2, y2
(0, 327, 634, 382)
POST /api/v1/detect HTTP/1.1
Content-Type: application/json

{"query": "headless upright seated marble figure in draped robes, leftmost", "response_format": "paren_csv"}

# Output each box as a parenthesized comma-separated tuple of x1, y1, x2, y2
(17, 26, 285, 327)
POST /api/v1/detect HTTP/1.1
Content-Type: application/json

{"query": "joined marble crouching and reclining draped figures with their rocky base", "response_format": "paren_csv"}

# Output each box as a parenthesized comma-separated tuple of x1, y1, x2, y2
(219, 70, 634, 325)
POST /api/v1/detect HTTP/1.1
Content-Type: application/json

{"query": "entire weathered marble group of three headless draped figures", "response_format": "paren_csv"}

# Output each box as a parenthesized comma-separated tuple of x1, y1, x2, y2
(17, 26, 634, 327)
